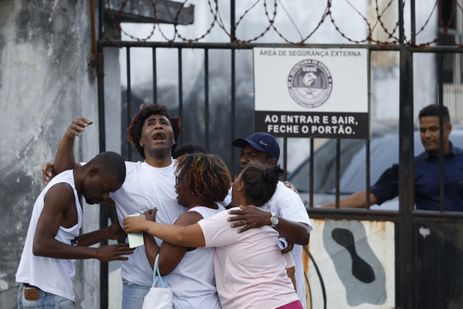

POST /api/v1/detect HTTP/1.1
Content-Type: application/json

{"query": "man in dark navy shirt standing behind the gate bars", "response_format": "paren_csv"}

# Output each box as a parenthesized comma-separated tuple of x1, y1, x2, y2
(322, 104, 463, 211)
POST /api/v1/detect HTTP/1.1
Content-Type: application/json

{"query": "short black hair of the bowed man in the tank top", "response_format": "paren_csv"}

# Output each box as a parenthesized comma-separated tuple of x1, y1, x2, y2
(86, 151, 126, 184)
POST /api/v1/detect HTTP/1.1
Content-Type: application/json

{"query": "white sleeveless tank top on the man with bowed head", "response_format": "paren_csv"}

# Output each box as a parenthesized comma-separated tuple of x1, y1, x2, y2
(16, 170, 82, 301)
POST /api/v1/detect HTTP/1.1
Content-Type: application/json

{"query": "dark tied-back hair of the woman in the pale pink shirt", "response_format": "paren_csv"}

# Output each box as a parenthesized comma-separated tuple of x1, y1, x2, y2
(240, 162, 284, 206)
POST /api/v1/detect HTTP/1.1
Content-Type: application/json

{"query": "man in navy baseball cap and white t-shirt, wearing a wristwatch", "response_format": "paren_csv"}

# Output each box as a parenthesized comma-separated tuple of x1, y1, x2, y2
(229, 132, 312, 308)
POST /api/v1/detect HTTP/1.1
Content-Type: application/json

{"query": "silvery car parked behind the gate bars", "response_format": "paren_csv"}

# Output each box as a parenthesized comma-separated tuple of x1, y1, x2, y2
(288, 128, 463, 210)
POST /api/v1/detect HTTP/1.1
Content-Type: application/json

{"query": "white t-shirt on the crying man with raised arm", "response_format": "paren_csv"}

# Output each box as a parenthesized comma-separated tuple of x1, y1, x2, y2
(110, 160, 185, 287)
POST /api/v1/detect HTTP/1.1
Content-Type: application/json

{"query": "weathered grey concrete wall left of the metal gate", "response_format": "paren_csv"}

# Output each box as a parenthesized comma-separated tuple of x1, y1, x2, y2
(0, 0, 103, 308)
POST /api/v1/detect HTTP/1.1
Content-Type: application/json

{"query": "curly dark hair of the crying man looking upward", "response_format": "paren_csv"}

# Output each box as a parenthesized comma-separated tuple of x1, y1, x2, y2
(127, 103, 185, 158)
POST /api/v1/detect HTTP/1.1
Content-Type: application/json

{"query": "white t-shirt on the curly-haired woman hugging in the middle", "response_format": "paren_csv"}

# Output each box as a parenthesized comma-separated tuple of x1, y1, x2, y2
(164, 206, 225, 309)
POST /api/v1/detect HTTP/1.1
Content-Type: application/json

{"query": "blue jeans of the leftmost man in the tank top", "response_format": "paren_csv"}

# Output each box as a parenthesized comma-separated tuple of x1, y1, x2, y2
(18, 284, 76, 309)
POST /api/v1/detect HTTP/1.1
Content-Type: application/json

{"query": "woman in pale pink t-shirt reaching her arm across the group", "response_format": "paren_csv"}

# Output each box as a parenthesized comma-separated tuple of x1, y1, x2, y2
(124, 165, 302, 309)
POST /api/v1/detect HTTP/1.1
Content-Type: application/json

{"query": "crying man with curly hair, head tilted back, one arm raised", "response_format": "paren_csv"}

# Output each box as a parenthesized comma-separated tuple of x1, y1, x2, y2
(48, 104, 184, 309)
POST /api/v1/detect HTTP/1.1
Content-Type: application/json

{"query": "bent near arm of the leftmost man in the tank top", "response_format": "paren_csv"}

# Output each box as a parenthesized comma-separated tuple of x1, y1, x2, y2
(33, 183, 132, 261)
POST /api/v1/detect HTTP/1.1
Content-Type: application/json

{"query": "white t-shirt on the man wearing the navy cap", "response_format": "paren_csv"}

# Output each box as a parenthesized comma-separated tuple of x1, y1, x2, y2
(262, 181, 313, 308)
